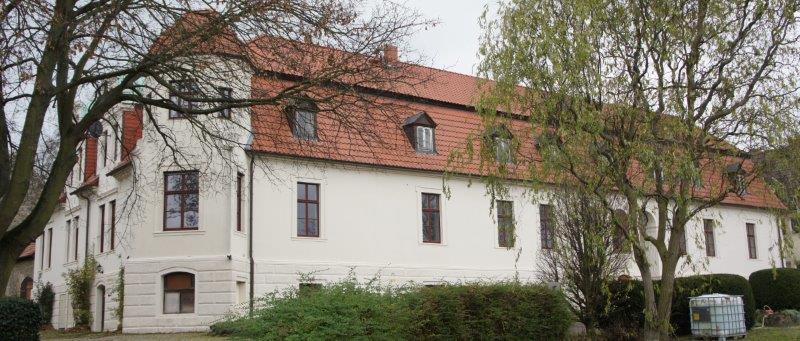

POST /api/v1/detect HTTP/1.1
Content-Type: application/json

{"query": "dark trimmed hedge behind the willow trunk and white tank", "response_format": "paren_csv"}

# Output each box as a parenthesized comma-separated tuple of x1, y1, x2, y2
(601, 274, 756, 337)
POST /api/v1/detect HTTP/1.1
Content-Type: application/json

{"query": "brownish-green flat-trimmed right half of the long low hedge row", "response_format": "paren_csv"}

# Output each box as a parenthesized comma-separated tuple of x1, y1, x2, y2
(411, 283, 573, 340)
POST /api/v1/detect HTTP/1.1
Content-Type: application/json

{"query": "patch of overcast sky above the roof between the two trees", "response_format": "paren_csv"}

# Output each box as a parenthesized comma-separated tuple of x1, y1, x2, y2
(396, 0, 496, 74)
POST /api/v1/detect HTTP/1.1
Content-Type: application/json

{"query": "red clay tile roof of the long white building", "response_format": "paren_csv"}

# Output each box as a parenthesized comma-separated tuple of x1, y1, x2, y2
(161, 14, 784, 209)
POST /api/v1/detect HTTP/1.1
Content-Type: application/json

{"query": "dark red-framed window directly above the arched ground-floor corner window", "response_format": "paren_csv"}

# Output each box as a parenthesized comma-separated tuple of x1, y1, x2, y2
(164, 171, 200, 231)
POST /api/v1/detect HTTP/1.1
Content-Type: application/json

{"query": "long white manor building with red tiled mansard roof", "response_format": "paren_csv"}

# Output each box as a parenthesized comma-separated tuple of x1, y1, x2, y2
(34, 16, 782, 333)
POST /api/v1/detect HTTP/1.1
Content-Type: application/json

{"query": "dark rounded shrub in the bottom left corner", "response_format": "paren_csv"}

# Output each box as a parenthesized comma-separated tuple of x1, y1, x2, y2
(0, 297, 42, 340)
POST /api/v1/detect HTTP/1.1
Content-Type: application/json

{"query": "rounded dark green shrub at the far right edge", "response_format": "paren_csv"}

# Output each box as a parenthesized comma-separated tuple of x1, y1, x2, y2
(750, 269, 800, 311)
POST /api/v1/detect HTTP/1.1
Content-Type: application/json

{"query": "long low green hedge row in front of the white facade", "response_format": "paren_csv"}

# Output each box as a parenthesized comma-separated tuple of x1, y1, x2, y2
(211, 282, 574, 340)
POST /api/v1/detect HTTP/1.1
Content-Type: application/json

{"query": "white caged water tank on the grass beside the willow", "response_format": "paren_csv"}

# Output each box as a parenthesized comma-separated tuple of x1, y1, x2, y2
(689, 294, 747, 340)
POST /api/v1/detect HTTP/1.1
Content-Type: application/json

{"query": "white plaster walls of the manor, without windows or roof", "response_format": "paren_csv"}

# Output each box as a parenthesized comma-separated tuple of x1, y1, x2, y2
(35, 59, 781, 333)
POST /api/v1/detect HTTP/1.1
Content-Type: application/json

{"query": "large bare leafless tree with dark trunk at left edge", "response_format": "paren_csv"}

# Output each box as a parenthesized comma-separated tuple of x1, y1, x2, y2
(0, 0, 426, 294)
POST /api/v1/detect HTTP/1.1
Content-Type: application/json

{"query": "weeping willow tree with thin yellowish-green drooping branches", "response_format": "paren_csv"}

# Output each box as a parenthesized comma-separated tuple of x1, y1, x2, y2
(478, 0, 800, 339)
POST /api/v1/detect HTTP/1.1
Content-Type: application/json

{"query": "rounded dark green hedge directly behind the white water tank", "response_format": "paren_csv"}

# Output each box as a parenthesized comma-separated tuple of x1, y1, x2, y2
(670, 274, 756, 335)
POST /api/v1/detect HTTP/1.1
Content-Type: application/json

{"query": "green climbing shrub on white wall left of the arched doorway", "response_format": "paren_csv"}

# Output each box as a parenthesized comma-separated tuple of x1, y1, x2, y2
(64, 255, 97, 329)
